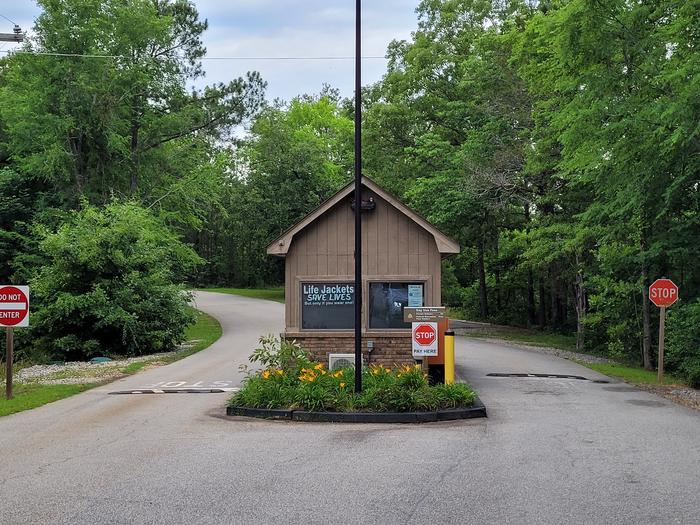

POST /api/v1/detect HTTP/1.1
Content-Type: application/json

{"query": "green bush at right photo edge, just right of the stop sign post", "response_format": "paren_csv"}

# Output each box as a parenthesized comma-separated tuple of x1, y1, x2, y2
(664, 300, 700, 388)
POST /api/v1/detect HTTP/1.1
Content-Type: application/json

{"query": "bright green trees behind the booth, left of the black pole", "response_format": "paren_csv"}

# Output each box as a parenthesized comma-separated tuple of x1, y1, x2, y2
(191, 89, 354, 288)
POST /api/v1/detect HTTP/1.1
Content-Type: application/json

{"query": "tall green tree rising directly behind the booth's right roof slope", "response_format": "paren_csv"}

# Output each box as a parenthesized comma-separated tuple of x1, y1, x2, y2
(367, 0, 531, 319)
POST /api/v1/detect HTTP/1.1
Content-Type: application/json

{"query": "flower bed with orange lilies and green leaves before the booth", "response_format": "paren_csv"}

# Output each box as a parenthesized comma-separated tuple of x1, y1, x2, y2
(230, 338, 476, 412)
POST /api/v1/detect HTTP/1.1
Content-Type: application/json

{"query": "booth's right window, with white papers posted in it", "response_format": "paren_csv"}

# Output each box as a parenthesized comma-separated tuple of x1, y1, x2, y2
(369, 282, 425, 328)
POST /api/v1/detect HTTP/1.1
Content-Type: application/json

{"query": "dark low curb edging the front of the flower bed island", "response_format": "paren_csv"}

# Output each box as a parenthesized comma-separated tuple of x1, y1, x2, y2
(226, 397, 488, 423)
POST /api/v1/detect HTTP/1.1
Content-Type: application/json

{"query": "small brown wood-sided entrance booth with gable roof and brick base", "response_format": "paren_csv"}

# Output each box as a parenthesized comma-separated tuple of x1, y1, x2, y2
(267, 177, 459, 366)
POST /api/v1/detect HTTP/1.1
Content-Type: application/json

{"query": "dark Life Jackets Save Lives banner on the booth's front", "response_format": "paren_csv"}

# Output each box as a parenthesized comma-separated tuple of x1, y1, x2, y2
(301, 282, 355, 330)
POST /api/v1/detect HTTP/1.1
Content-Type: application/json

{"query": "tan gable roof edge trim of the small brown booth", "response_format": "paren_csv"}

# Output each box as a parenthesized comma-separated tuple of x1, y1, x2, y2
(267, 176, 459, 257)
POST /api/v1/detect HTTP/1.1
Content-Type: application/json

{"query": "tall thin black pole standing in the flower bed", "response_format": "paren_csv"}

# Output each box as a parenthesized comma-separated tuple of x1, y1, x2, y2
(355, 0, 362, 392)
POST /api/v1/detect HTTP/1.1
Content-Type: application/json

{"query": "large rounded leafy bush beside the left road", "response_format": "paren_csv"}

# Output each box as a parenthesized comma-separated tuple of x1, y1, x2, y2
(31, 203, 200, 359)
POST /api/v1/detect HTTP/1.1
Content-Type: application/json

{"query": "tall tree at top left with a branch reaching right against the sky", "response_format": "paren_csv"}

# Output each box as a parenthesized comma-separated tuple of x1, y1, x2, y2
(0, 0, 265, 206)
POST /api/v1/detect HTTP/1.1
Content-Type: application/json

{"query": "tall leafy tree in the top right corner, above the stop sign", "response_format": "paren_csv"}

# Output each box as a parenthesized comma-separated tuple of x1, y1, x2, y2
(523, 0, 700, 368)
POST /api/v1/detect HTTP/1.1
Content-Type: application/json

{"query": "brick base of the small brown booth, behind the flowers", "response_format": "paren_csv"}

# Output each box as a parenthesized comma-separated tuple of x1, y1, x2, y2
(282, 333, 415, 367)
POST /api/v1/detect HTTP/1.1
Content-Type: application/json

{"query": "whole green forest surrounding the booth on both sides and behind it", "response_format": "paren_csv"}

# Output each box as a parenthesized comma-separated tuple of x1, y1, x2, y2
(0, 0, 700, 385)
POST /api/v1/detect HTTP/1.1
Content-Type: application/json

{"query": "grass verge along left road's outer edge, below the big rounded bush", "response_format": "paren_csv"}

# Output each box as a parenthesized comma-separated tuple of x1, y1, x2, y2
(0, 312, 222, 417)
